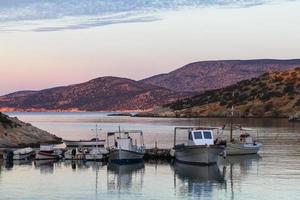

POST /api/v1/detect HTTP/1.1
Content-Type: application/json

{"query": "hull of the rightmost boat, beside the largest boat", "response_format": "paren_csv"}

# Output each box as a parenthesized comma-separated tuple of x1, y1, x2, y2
(226, 143, 262, 156)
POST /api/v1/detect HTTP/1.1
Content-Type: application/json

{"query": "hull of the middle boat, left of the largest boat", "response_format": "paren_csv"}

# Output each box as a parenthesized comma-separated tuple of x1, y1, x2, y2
(109, 149, 144, 164)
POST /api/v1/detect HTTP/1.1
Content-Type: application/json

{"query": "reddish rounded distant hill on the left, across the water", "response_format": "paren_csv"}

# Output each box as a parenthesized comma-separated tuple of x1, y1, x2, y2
(0, 77, 187, 111)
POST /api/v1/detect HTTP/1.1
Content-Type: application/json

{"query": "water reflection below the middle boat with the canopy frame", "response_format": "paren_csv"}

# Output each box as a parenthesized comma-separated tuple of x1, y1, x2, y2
(107, 162, 145, 191)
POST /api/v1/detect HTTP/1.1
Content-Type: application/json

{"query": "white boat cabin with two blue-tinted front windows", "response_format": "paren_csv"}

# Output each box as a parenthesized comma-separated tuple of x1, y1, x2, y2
(188, 130, 214, 145)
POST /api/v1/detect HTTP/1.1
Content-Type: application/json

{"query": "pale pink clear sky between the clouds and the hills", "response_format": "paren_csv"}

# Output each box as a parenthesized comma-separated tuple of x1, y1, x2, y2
(0, 2, 300, 95)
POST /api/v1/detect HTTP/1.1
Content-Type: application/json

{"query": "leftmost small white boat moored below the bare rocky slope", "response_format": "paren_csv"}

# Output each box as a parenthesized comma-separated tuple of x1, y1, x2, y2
(3, 147, 35, 160)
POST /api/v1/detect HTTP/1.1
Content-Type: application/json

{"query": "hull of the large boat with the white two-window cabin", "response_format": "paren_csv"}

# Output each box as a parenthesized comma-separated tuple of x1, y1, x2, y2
(175, 145, 224, 165)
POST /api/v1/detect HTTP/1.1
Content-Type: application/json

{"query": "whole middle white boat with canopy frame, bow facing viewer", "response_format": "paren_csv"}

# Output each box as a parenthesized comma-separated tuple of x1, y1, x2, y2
(107, 128, 145, 164)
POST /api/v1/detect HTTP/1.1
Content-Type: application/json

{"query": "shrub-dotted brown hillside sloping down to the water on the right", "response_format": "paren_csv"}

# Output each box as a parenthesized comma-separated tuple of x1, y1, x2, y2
(140, 68, 300, 117)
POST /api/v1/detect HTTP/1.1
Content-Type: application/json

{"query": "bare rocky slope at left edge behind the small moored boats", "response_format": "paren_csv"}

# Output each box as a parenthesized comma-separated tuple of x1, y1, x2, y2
(0, 113, 61, 148)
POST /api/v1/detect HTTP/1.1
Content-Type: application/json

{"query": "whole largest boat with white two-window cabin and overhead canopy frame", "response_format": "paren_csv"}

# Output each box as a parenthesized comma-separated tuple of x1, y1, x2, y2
(174, 127, 225, 165)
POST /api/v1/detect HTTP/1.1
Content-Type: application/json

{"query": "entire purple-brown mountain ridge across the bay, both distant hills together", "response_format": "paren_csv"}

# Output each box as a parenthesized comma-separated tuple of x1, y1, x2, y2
(0, 59, 300, 111)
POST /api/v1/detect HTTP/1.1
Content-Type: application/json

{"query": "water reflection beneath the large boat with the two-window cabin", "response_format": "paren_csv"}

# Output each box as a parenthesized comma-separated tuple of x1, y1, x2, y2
(173, 162, 226, 197)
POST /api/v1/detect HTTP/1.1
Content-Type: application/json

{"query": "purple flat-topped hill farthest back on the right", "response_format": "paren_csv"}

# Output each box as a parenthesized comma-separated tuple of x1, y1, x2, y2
(141, 59, 300, 92)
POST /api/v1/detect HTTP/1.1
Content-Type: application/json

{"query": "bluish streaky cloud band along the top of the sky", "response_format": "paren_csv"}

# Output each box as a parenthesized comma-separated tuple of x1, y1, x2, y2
(0, 0, 268, 31)
